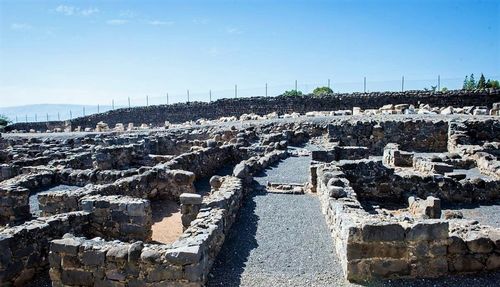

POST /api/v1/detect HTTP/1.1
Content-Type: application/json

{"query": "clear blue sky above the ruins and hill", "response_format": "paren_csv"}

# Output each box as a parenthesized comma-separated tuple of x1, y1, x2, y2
(0, 0, 500, 106)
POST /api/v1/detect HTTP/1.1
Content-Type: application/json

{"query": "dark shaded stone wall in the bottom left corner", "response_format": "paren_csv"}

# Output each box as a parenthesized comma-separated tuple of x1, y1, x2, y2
(0, 212, 89, 286)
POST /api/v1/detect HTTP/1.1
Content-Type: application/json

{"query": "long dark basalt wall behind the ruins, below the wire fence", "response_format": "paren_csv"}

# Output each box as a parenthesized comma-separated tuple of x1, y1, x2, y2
(6, 90, 500, 131)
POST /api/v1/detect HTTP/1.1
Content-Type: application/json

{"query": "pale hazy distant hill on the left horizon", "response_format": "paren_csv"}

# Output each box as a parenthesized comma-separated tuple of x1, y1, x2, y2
(0, 104, 119, 123)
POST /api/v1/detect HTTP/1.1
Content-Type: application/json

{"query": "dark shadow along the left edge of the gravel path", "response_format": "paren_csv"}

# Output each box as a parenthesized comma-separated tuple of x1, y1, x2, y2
(206, 181, 266, 286)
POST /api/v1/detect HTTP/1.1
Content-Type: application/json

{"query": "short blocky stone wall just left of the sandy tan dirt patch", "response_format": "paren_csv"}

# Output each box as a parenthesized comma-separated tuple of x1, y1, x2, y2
(79, 195, 153, 242)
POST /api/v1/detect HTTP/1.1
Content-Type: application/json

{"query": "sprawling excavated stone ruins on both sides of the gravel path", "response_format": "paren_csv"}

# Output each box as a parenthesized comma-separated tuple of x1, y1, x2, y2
(0, 102, 500, 286)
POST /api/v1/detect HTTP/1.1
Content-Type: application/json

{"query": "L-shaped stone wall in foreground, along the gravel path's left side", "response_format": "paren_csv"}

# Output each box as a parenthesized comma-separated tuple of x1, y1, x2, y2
(50, 177, 243, 286)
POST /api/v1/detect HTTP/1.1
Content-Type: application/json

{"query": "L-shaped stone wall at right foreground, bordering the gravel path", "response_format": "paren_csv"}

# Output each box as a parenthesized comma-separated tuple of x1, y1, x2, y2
(314, 164, 500, 281)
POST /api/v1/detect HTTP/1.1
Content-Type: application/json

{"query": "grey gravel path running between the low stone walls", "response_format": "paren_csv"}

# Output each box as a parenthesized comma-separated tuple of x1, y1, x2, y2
(207, 154, 347, 286)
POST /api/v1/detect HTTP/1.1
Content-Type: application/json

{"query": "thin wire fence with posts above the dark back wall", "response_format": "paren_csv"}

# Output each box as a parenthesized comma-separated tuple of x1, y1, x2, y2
(5, 76, 498, 123)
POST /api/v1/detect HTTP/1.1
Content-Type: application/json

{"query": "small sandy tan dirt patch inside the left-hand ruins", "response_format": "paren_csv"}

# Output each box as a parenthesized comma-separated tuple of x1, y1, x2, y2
(151, 200, 186, 243)
